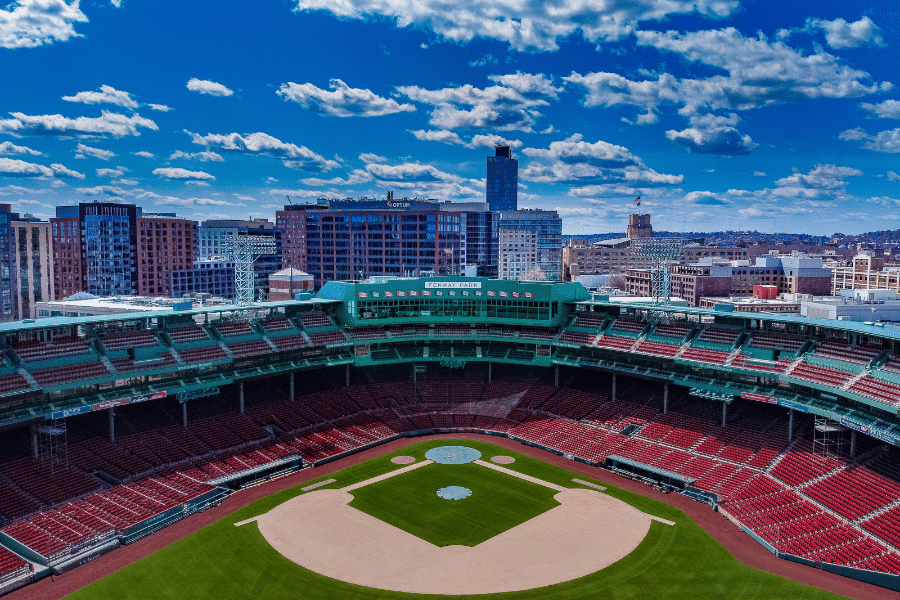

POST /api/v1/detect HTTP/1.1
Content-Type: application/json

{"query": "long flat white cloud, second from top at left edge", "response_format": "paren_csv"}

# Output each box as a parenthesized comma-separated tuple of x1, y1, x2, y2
(0, 110, 159, 137)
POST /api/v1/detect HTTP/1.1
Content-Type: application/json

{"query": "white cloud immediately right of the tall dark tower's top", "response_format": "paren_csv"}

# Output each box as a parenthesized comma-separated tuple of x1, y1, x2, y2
(519, 134, 684, 185)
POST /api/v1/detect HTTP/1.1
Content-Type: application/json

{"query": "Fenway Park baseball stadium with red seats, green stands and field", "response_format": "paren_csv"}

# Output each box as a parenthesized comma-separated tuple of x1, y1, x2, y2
(0, 277, 900, 599)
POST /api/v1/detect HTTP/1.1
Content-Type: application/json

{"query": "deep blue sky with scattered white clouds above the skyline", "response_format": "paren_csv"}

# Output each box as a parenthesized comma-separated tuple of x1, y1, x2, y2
(0, 0, 900, 234)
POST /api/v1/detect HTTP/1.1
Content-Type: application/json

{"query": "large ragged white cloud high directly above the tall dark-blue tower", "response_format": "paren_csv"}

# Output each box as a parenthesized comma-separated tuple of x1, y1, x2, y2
(397, 73, 563, 132)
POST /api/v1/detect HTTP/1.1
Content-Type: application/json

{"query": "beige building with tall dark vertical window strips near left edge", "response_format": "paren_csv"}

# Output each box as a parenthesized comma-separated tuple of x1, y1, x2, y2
(12, 220, 55, 319)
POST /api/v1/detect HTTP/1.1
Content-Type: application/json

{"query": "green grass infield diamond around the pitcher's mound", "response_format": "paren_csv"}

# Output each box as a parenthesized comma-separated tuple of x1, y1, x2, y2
(350, 463, 559, 546)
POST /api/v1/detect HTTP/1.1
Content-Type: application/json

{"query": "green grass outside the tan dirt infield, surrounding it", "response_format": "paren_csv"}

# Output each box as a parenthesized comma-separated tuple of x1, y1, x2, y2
(70, 439, 839, 600)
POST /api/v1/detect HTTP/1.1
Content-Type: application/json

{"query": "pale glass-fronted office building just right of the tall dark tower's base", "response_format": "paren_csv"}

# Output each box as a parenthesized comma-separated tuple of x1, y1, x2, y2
(498, 208, 562, 281)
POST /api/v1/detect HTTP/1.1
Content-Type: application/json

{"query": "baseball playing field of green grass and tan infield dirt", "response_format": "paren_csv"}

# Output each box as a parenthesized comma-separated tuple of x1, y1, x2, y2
(63, 439, 839, 600)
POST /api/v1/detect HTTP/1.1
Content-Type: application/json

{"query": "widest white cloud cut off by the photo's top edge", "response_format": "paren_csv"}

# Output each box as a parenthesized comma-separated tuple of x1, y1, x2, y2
(295, 0, 739, 52)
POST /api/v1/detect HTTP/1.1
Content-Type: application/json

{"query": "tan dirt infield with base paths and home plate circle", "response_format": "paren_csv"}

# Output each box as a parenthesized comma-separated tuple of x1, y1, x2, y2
(250, 446, 668, 594)
